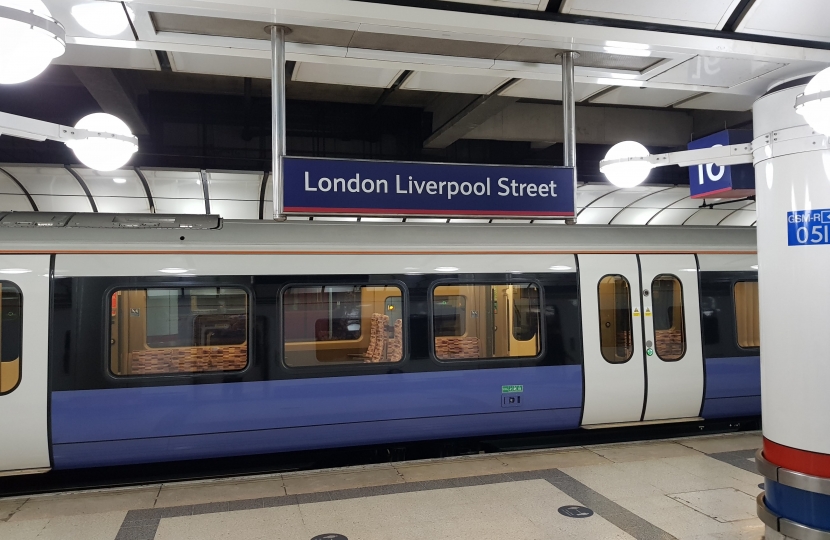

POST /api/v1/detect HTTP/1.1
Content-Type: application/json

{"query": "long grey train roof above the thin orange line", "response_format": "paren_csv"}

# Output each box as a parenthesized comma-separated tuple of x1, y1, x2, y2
(0, 213, 756, 254)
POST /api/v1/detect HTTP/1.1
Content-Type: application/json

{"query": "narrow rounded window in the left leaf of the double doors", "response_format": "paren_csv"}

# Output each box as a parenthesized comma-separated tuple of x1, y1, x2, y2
(597, 275, 634, 364)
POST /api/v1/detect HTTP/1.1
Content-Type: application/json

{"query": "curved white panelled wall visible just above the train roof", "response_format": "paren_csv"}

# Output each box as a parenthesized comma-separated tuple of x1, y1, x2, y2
(0, 164, 756, 227)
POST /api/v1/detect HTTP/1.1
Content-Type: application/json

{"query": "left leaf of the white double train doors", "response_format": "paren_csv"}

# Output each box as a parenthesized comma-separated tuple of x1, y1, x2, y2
(579, 255, 645, 425)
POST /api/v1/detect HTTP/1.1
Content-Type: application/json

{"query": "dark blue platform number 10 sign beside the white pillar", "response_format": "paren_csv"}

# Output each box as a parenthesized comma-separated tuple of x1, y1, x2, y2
(688, 129, 755, 199)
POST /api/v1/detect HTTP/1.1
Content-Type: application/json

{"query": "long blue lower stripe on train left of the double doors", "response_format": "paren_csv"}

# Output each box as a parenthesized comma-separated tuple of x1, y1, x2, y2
(52, 365, 582, 469)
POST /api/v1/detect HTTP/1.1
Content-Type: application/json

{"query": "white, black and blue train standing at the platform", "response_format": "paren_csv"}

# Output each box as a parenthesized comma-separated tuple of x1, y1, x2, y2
(0, 212, 761, 475)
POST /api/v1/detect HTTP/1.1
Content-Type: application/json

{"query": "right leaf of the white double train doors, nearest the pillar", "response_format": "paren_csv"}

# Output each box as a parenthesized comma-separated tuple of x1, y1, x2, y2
(640, 255, 703, 420)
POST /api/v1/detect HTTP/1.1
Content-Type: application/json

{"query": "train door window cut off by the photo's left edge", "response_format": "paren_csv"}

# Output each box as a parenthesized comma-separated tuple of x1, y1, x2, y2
(0, 281, 23, 395)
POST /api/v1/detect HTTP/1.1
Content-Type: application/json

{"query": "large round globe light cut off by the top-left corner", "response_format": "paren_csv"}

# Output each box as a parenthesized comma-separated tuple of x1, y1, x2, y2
(0, 0, 66, 84)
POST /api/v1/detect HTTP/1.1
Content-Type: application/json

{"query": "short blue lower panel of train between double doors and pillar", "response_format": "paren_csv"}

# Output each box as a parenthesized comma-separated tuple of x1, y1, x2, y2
(701, 356, 761, 418)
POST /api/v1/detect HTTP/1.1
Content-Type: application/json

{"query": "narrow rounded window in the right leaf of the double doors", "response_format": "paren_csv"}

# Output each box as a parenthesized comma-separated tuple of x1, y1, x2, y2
(651, 274, 686, 362)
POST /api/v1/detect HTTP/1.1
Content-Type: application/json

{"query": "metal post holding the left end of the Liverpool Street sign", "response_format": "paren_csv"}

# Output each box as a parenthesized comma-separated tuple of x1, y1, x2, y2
(267, 25, 287, 221)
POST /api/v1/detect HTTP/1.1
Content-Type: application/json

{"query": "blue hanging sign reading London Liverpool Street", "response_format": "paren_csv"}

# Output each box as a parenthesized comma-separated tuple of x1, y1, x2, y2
(283, 157, 575, 219)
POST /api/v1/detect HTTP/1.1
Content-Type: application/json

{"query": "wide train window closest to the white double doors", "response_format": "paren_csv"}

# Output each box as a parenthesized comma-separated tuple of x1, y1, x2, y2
(432, 283, 541, 360)
